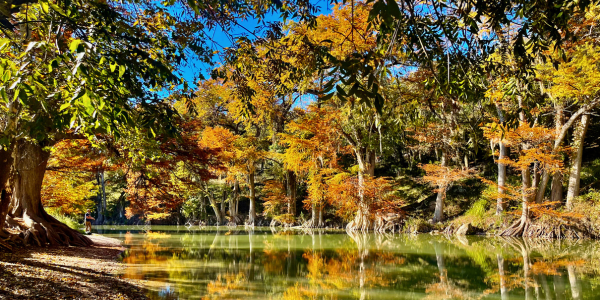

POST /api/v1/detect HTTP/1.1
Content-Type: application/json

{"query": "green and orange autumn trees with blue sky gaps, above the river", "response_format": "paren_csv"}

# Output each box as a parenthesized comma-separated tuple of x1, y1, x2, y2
(0, 0, 600, 248)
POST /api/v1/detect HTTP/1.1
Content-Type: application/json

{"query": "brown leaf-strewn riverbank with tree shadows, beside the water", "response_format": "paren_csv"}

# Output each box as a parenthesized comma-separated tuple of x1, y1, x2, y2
(0, 235, 147, 299)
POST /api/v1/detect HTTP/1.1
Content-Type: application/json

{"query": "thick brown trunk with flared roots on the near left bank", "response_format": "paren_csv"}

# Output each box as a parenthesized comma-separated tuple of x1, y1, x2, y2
(7, 141, 92, 246)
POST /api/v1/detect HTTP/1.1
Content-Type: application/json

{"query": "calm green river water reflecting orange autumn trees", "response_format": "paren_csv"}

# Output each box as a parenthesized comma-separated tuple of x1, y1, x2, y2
(95, 226, 600, 300)
